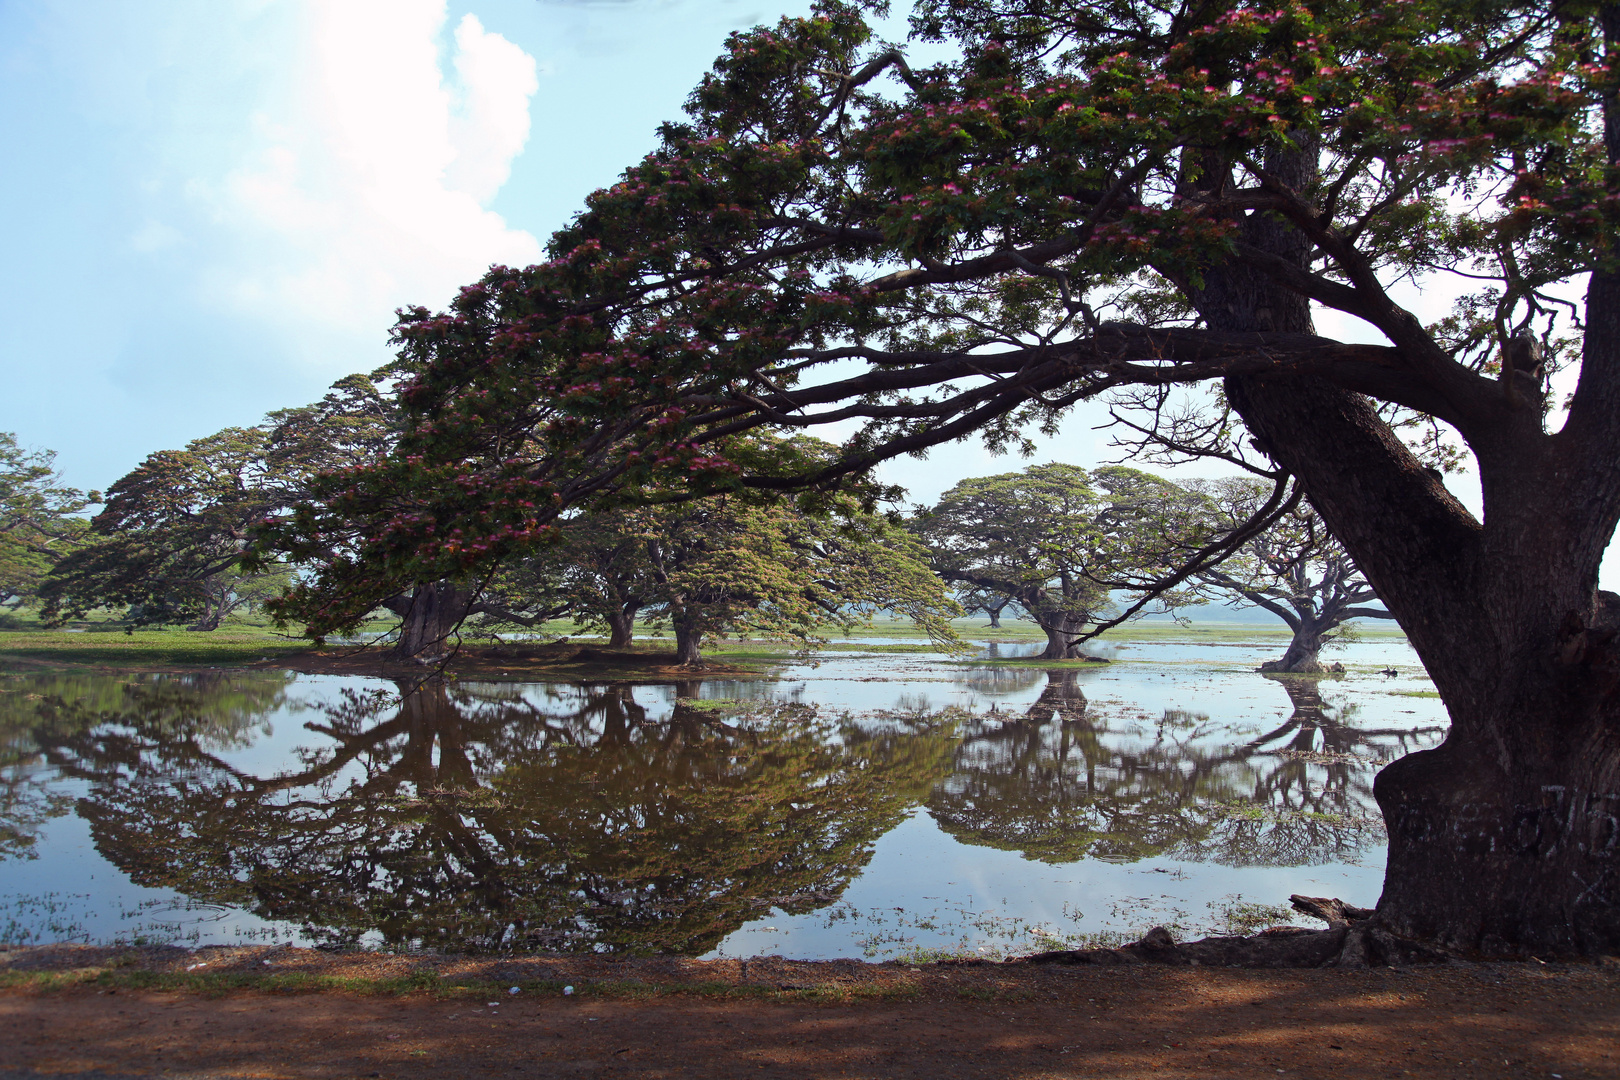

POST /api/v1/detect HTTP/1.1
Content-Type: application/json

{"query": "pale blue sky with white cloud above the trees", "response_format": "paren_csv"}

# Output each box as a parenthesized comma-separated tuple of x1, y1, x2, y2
(0, 0, 1620, 581)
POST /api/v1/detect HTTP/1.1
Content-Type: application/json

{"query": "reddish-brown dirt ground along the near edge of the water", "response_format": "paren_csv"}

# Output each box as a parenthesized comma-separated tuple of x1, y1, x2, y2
(0, 947, 1620, 1080)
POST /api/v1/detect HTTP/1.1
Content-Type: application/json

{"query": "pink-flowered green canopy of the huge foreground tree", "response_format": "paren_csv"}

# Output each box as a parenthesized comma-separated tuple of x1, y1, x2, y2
(255, 0, 1617, 627)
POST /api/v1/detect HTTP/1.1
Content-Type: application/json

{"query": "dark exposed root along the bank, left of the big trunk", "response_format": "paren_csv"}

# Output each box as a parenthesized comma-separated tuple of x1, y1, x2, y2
(1013, 895, 1453, 968)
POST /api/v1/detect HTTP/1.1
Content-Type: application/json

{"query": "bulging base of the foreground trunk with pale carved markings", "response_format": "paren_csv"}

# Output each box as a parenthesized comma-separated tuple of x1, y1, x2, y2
(1374, 689, 1620, 959)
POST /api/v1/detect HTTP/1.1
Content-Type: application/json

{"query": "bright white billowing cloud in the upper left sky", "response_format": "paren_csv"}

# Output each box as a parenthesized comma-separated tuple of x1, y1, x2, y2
(191, 0, 539, 351)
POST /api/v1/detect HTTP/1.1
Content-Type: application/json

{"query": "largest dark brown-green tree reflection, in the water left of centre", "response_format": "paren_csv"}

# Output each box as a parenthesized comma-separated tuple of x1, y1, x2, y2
(6, 682, 954, 954)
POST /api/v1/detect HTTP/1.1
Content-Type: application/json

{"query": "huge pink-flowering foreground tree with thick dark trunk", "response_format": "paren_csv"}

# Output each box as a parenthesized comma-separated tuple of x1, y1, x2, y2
(265, 0, 1620, 957)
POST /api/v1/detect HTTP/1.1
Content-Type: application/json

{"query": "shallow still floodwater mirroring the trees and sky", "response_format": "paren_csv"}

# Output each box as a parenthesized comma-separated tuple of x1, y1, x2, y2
(0, 640, 1445, 959)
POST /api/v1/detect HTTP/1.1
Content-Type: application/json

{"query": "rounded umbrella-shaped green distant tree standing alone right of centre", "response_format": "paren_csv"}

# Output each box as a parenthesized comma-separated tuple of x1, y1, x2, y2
(912, 463, 1209, 661)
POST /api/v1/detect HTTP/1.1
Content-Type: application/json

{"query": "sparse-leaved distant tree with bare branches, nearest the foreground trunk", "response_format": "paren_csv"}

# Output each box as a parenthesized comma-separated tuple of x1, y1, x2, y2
(1194, 478, 1393, 672)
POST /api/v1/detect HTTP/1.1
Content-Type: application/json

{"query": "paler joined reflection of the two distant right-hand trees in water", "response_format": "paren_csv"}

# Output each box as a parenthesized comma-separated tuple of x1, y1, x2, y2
(928, 669, 1443, 866)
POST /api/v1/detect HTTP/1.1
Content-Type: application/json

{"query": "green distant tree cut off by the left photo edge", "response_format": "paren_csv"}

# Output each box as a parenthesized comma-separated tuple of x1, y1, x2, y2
(0, 432, 100, 606)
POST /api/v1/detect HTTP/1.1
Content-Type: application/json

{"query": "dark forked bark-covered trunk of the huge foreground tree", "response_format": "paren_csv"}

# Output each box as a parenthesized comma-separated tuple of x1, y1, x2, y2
(1197, 124, 1620, 957)
